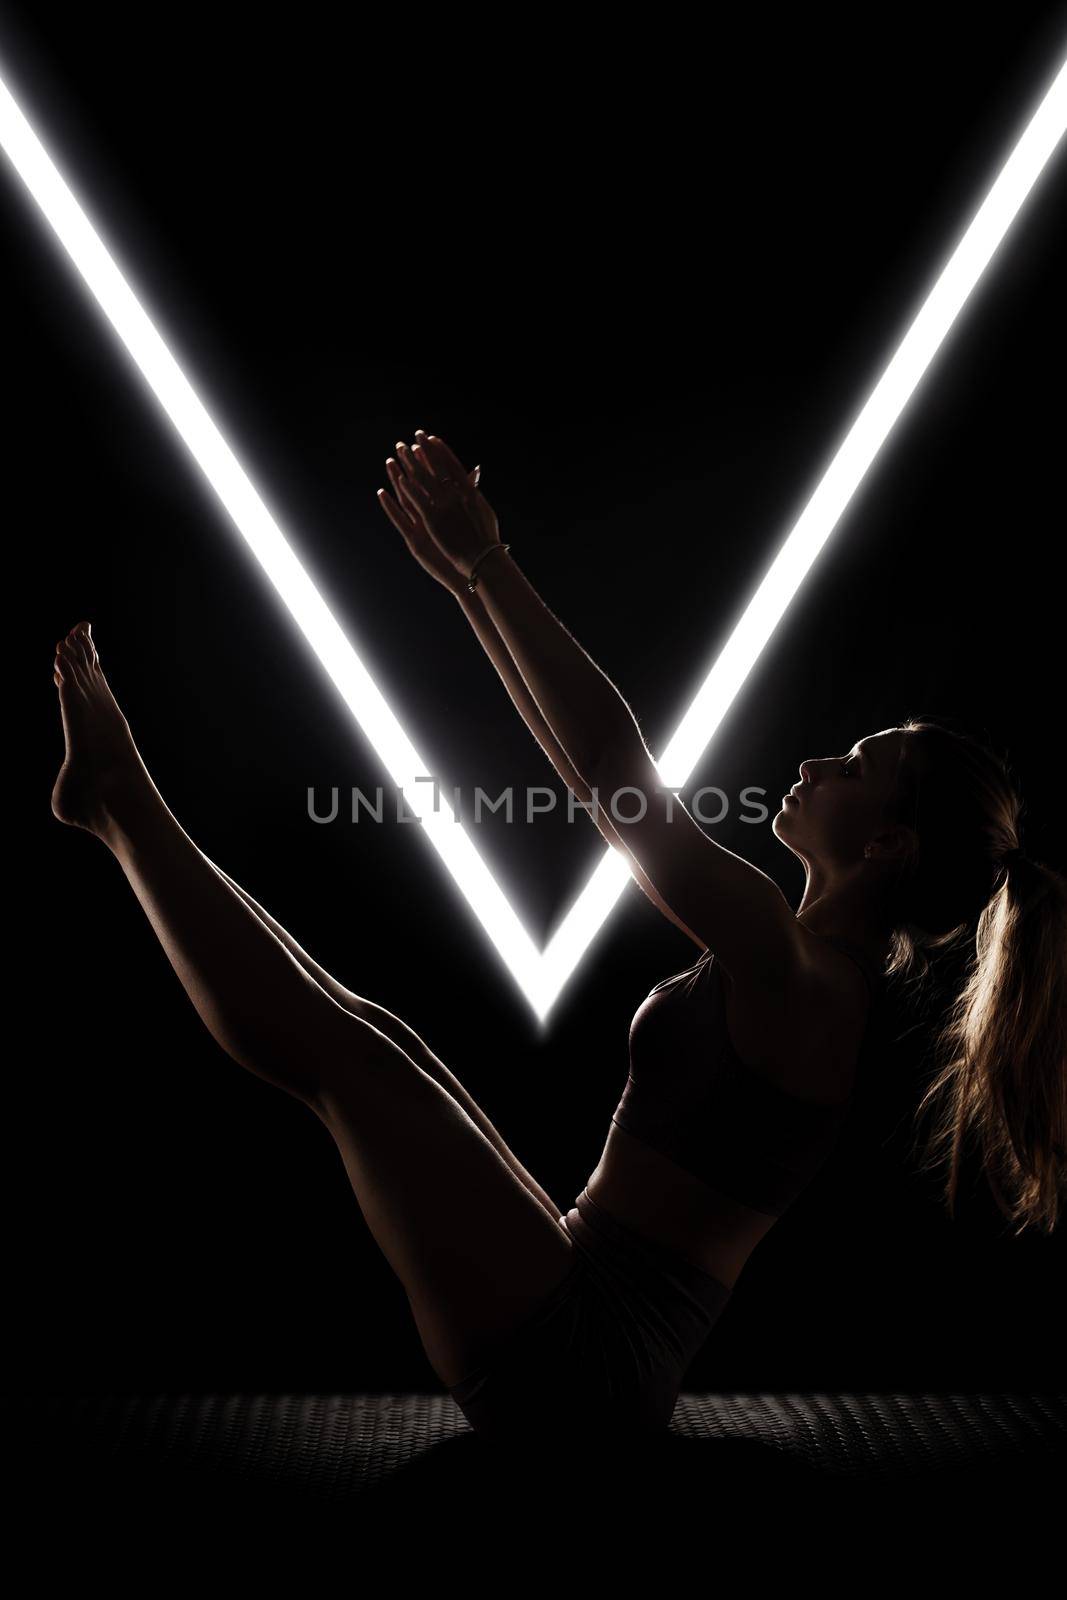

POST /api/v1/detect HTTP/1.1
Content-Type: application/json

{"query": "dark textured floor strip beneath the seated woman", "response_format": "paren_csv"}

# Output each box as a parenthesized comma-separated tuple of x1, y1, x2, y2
(3, 1394, 1067, 1509)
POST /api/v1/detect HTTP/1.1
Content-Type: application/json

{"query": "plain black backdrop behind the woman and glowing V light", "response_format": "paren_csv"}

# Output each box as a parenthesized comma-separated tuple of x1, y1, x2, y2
(0, 3, 1067, 1392)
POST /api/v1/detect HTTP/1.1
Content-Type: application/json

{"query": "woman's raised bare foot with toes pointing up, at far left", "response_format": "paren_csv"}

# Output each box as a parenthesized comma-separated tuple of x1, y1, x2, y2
(51, 622, 152, 837)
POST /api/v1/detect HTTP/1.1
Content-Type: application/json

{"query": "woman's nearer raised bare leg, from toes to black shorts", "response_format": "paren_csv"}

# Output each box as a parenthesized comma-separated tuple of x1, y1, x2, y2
(53, 626, 573, 1384)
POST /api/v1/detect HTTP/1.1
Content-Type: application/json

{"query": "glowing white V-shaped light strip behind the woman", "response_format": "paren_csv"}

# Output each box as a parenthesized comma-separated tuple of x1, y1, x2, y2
(0, 53, 1067, 1024)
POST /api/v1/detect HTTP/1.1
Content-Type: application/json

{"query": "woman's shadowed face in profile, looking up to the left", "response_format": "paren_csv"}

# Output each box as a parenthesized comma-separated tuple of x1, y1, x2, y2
(771, 728, 907, 867)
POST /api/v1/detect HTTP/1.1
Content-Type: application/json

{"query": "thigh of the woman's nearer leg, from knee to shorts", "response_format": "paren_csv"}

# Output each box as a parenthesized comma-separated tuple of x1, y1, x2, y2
(303, 1008, 574, 1384)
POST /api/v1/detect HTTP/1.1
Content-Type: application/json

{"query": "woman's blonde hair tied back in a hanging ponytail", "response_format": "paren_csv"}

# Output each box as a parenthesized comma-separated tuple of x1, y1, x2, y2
(886, 717, 1067, 1235)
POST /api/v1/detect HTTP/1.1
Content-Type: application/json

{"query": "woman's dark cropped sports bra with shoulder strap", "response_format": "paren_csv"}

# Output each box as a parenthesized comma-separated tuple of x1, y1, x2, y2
(611, 938, 883, 1216)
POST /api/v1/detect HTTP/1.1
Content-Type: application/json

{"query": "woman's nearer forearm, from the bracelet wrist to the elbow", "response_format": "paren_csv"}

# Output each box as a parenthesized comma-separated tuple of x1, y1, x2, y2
(472, 552, 640, 779)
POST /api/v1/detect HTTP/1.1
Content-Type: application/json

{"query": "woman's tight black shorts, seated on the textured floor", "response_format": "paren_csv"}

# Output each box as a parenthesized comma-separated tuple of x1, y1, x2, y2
(448, 1189, 731, 1443)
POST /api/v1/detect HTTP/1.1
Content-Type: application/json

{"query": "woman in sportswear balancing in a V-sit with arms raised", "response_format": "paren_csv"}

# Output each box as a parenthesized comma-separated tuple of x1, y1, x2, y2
(53, 432, 1067, 1442)
